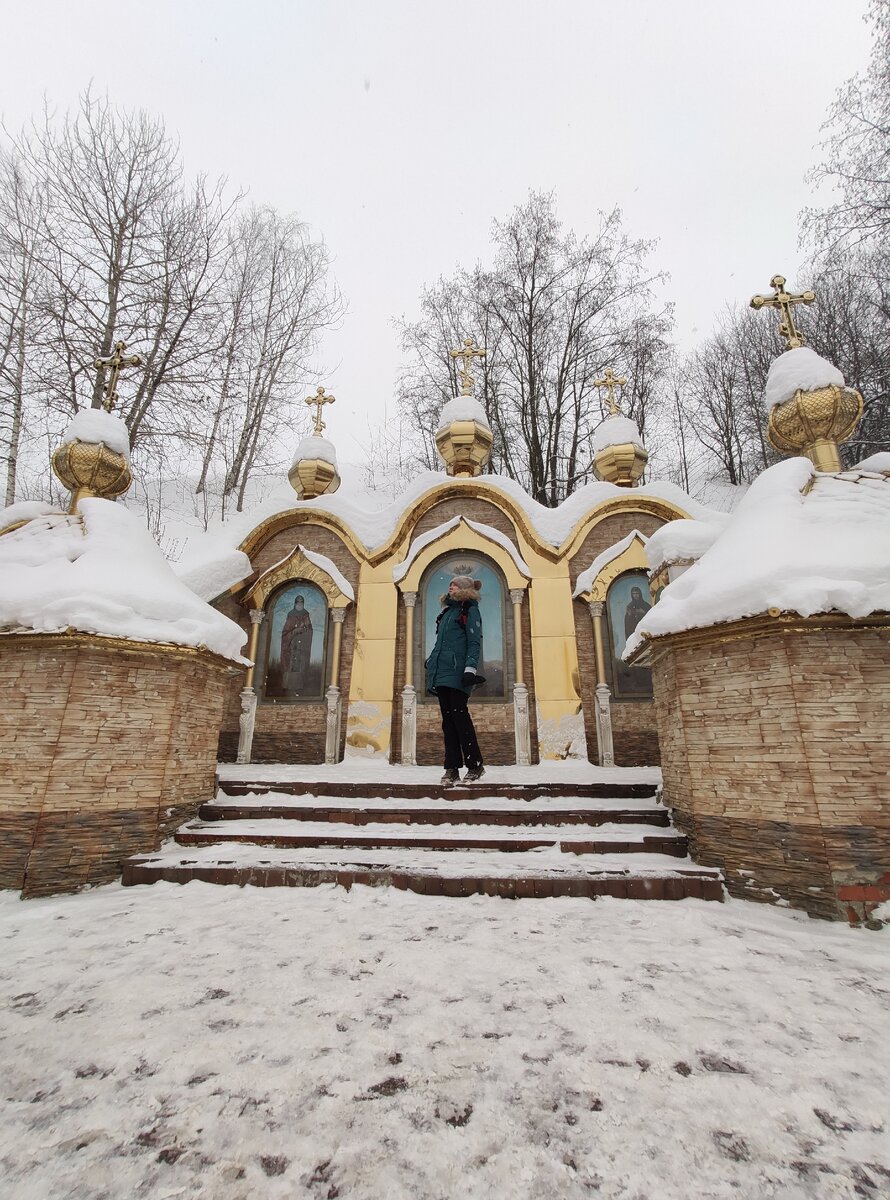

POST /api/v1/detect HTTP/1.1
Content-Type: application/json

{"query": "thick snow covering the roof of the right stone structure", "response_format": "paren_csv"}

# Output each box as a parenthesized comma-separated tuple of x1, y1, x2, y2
(625, 458, 890, 654)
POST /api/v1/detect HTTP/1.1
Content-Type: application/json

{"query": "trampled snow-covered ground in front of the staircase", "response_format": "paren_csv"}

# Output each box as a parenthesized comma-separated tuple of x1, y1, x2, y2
(0, 883, 890, 1200)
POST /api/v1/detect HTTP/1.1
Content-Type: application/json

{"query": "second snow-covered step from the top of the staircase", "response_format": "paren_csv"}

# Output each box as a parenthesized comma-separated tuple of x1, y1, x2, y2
(199, 791, 670, 827)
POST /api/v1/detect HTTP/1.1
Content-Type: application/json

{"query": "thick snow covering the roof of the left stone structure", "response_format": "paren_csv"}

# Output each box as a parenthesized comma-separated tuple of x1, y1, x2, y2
(0, 498, 247, 661)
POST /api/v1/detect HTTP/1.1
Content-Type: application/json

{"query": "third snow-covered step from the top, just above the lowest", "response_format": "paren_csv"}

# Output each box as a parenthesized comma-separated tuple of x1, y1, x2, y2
(176, 814, 686, 857)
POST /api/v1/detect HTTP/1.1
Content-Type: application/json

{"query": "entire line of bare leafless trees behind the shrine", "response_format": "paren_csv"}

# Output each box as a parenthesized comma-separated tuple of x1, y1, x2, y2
(0, 0, 890, 518)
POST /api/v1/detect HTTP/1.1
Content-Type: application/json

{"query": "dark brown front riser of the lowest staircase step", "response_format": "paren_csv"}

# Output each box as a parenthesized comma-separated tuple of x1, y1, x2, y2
(121, 858, 723, 901)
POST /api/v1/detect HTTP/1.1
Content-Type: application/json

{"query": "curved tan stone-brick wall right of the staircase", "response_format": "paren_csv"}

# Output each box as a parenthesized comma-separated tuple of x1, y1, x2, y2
(651, 617, 890, 922)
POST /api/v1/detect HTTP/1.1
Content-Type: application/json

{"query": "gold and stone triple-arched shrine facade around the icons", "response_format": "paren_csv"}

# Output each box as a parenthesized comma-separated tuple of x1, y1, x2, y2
(218, 480, 687, 764)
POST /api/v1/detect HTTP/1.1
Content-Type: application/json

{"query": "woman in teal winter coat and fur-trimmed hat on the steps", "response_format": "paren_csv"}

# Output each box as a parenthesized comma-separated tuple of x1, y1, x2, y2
(426, 575, 485, 786)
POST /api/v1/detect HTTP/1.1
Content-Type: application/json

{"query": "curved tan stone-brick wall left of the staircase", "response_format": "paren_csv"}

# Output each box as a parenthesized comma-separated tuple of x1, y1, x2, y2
(0, 635, 231, 896)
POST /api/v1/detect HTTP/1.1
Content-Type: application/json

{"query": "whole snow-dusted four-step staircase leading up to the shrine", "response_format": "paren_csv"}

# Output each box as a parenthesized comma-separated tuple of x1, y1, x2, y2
(122, 767, 723, 900)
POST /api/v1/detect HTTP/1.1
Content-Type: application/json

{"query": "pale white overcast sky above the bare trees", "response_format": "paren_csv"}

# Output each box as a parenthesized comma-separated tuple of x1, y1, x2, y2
(0, 0, 870, 461)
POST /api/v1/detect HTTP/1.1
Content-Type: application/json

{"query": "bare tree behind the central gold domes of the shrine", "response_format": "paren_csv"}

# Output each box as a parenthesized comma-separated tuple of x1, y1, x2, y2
(398, 193, 670, 505)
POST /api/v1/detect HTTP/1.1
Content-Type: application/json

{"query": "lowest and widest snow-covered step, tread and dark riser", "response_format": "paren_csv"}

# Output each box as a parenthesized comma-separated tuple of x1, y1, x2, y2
(122, 842, 722, 900)
